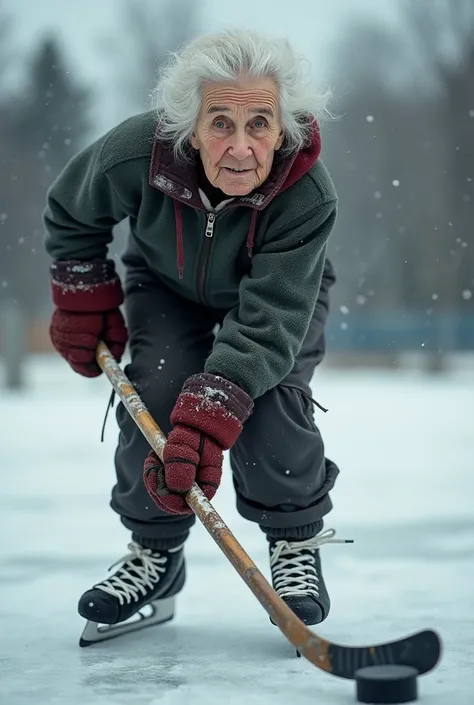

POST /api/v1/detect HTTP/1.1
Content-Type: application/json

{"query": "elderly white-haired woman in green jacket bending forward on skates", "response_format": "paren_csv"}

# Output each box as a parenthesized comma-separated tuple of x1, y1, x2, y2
(44, 31, 339, 640)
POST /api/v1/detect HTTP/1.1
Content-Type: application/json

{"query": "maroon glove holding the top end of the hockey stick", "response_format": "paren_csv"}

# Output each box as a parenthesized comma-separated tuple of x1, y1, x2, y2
(49, 260, 128, 377)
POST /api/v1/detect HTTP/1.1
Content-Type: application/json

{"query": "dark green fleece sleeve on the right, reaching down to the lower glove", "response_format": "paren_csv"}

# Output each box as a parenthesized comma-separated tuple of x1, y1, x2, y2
(205, 200, 337, 399)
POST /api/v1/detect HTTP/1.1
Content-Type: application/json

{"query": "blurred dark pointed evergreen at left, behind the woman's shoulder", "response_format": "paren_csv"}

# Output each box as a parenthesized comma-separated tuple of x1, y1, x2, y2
(0, 37, 89, 316)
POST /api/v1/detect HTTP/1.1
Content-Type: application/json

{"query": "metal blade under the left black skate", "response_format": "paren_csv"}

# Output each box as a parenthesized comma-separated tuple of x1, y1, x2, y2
(79, 597, 175, 646)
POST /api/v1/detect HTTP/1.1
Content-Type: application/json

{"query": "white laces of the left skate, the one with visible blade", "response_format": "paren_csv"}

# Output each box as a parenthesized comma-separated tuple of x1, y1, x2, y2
(94, 542, 181, 605)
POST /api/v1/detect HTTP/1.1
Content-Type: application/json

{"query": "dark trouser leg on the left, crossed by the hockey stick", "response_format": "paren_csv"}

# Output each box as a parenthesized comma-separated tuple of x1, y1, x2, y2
(110, 266, 215, 548)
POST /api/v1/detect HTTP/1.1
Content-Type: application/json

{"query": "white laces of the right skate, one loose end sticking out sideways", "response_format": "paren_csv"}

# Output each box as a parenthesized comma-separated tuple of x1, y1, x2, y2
(270, 529, 352, 598)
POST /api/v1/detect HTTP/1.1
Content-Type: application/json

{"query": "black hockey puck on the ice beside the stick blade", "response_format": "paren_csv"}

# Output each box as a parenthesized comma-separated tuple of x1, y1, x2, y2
(355, 665, 418, 703)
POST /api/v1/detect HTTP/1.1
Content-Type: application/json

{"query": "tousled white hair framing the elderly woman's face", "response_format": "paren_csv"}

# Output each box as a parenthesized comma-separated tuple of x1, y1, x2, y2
(151, 29, 330, 160)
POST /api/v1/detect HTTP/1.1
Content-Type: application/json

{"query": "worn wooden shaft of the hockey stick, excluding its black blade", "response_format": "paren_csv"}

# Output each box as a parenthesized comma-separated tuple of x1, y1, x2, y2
(97, 342, 332, 672)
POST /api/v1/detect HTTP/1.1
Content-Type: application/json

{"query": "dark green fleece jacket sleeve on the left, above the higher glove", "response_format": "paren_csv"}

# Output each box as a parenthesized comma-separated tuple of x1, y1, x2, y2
(43, 136, 128, 260)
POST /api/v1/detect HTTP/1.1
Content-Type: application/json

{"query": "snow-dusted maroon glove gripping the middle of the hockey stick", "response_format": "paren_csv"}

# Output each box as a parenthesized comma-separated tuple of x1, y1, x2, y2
(143, 373, 253, 514)
